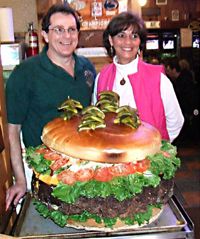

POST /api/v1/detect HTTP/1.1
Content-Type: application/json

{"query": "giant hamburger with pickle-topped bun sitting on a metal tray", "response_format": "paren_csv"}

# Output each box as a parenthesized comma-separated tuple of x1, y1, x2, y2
(27, 91, 180, 231)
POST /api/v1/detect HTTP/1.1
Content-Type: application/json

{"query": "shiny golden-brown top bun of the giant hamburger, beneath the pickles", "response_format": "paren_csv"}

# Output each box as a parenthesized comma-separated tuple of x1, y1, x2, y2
(41, 113, 161, 163)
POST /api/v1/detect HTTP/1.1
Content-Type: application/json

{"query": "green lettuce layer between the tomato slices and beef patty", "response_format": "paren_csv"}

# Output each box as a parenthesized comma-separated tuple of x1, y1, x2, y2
(52, 173, 160, 203)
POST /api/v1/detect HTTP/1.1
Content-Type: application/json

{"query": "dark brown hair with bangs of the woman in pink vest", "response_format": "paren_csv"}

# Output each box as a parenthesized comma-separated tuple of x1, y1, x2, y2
(103, 12, 146, 57)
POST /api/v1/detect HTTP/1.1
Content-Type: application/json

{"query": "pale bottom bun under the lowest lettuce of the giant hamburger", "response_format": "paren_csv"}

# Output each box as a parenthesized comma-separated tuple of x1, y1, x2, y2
(66, 206, 164, 232)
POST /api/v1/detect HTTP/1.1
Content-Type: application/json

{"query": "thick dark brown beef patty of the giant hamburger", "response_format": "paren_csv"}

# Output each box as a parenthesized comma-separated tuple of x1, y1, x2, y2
(32, 178, 173, 218)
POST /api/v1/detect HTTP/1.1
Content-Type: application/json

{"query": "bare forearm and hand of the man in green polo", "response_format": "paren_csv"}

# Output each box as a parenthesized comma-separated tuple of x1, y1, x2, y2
(6, 124, 27, 210)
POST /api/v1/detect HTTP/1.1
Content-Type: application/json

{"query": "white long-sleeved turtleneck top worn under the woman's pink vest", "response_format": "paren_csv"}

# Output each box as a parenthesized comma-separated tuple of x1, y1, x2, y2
(92, 56, 184, 142)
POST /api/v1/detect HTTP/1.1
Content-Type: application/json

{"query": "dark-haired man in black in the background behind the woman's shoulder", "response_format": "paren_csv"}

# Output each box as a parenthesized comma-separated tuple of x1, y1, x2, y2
(165, 58, 199, 143)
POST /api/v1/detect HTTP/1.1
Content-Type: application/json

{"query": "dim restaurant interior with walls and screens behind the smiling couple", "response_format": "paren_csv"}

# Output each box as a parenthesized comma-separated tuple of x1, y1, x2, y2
(0, 0, 200, 239)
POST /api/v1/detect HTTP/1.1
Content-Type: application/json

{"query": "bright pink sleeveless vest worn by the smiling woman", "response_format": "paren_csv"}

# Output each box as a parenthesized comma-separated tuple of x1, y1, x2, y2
(97, 60, 169, 140)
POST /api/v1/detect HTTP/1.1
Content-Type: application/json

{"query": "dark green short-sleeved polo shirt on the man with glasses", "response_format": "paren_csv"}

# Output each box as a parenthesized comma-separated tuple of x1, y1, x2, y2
(6, 48, 96, 147)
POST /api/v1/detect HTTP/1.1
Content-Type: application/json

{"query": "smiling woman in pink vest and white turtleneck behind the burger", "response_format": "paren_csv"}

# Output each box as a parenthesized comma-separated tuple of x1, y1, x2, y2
(93, 12, 184, 142)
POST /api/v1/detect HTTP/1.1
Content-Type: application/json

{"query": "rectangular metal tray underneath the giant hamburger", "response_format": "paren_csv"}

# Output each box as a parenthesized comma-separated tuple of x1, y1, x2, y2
(13, 195, 194, 239)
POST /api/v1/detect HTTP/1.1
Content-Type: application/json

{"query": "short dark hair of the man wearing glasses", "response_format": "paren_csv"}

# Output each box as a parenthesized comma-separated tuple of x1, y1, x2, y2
(42, 4, 80, 33)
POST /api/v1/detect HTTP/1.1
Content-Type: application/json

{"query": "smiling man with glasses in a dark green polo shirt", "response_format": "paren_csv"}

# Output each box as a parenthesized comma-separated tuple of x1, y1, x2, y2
(6, 5, 96, 209)
